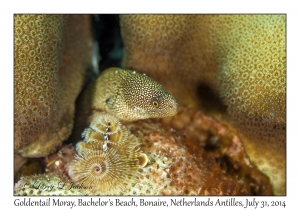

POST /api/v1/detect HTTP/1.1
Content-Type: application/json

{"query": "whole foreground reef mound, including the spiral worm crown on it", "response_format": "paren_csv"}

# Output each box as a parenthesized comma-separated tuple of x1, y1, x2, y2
(15, 107, 272, 195)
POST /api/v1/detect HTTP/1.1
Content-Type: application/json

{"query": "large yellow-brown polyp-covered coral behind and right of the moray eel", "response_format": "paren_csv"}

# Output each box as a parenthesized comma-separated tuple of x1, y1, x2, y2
(121, 15, 286, 194)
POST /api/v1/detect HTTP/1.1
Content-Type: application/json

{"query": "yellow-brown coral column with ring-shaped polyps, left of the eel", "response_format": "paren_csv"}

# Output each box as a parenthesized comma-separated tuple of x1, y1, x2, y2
(14, 15, 92, 157)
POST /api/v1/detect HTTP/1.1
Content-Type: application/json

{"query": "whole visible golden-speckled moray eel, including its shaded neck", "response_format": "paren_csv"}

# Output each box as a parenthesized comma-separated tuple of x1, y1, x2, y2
(74, 67, 178, 138)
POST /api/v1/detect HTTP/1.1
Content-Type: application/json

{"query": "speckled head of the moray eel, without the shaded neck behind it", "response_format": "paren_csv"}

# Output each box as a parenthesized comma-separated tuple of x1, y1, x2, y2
(107, 68, 178, 121)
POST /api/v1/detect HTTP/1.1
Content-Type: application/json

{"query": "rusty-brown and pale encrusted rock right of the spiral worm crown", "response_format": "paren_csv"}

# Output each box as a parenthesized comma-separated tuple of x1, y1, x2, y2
(124, 107, 272, 195)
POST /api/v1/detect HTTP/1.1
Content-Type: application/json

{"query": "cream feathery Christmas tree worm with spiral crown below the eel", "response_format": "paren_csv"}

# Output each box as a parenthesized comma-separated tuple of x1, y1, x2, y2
(69, 115, 148, 195)
